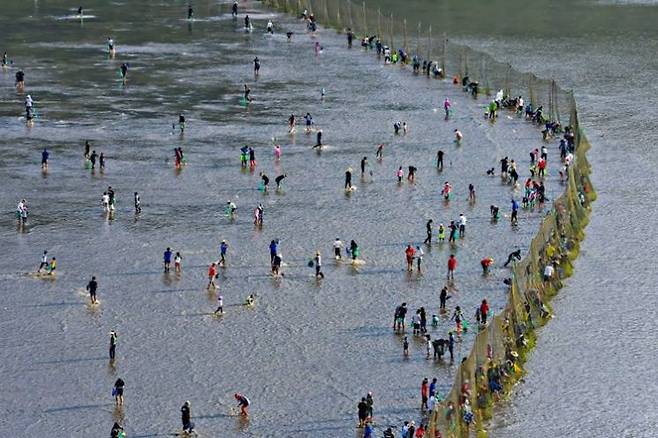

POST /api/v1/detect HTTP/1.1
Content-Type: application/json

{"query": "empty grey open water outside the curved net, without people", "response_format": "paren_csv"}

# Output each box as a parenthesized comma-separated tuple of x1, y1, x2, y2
(371, 0, 658, 437)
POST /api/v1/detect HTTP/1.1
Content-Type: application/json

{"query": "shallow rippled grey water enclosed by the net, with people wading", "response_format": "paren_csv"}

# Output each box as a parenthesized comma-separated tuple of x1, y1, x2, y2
(0, 1, 562, 437)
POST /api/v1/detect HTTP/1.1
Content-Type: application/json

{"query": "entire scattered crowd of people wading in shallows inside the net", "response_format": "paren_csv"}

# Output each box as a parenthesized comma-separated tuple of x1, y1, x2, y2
(3, 1, 574, 438)
